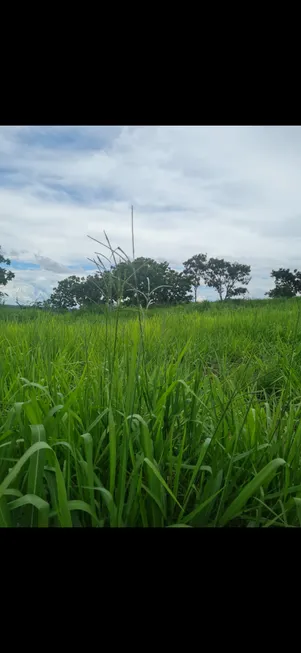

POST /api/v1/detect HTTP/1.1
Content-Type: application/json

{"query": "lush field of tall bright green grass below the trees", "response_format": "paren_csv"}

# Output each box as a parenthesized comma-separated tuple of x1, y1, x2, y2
(0, 300, 301, 527)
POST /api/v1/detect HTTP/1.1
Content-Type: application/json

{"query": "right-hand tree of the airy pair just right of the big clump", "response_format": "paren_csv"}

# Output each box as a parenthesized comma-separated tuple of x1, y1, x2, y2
(202, 258, 251, 301)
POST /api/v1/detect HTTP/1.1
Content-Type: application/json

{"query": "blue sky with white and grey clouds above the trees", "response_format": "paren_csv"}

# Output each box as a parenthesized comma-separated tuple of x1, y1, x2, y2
(0, 126, 301, 303)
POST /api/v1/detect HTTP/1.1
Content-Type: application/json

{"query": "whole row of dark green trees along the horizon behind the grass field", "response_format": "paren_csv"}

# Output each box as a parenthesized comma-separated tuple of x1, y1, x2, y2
(0, 246, 301, 309)
